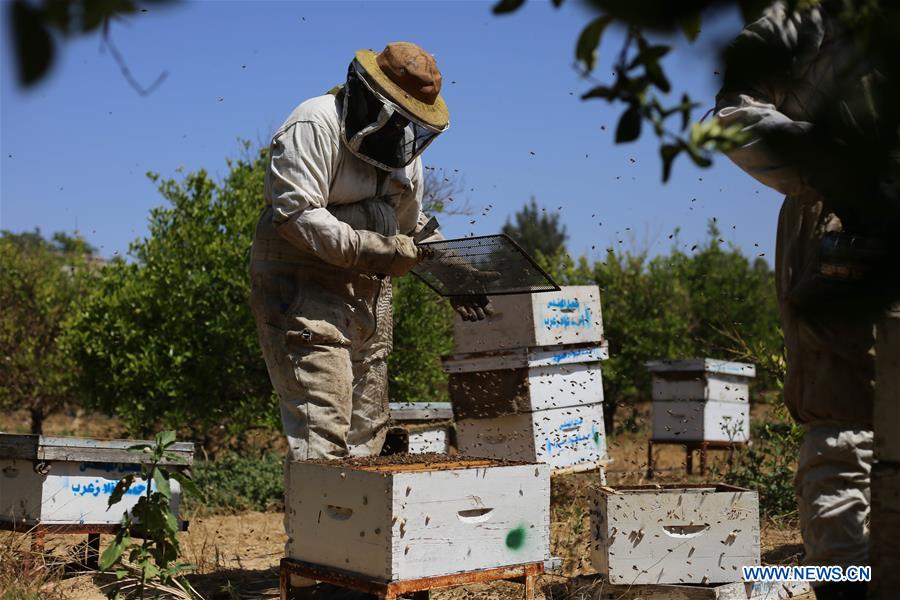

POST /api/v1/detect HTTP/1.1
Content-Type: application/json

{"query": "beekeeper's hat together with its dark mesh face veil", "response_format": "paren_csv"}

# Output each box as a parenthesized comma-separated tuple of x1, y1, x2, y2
(341, 42, 450, 171)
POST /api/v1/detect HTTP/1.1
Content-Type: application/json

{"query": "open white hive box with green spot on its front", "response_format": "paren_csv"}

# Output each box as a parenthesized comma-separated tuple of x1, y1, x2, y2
(285, 455, 550, 581)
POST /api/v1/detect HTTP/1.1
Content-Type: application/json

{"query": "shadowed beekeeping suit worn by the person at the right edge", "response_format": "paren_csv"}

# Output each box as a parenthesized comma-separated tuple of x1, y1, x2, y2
(716, 3, 874, 592)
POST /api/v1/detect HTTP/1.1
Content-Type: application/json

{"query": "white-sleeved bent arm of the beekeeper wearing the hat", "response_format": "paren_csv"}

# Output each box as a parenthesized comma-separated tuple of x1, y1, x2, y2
(267, 121, 418, 276)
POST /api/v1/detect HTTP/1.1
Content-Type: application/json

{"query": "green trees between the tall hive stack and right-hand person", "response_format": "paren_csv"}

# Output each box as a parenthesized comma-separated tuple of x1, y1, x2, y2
(542, 222, 783, 428)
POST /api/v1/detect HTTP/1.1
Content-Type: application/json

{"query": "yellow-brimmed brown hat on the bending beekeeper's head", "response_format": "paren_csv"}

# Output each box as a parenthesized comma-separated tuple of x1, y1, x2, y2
(356, 42, 450, 130)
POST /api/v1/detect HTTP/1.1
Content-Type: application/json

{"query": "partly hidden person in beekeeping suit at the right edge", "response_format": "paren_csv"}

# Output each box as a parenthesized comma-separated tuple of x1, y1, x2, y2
(716, 2, 896, 599)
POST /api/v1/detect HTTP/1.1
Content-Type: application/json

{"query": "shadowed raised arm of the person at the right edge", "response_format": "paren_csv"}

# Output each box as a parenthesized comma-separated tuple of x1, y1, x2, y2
(716, 3, 834, 195)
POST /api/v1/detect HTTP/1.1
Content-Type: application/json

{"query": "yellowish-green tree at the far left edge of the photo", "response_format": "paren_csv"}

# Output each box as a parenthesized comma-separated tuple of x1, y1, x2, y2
(0, 231, 93, 433)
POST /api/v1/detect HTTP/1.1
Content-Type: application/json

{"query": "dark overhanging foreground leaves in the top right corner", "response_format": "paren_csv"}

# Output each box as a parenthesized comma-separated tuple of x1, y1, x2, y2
(493, 0, 900, 181)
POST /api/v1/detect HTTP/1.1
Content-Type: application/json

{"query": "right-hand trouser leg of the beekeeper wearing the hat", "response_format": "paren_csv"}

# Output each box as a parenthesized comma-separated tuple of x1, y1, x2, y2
(347, 278, 393, 456)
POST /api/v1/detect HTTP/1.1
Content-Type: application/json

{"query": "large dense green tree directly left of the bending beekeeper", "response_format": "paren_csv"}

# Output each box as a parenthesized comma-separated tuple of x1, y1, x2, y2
(67, 144, 278, 442)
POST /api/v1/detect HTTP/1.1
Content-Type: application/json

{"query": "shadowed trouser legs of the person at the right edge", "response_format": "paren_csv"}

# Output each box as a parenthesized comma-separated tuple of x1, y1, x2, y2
(775, 198, 874, 597)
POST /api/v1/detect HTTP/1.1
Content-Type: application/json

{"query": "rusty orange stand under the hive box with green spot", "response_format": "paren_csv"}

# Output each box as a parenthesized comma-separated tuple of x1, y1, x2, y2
(279, 558, 544, 600)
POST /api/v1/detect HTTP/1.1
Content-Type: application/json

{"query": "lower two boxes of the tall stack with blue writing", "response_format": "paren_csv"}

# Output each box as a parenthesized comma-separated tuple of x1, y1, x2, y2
(444, 345, 609, 471)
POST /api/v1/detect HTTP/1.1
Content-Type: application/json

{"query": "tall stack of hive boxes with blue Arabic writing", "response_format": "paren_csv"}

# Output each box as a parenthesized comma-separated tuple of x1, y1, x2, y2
(444, 286, 608, 470)
